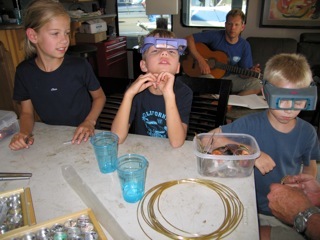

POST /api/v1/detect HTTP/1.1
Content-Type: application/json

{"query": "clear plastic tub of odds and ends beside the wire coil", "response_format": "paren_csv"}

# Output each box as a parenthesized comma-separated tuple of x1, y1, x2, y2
(193, 133, 260, 177)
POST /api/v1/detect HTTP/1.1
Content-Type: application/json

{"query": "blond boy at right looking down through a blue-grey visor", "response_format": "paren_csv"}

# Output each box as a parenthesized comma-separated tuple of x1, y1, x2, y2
(211, 54, 320, 240)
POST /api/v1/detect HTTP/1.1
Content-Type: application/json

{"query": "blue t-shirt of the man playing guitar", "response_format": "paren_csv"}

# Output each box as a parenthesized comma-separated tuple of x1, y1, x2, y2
(193, 30, 253, 69)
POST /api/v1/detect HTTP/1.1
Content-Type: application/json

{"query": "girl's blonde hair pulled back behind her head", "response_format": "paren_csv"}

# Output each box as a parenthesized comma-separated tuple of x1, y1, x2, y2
(23, 0, 70, 59)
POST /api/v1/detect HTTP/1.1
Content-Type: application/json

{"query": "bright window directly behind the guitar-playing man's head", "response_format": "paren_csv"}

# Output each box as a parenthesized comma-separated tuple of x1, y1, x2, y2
(182, 0, 247, 27)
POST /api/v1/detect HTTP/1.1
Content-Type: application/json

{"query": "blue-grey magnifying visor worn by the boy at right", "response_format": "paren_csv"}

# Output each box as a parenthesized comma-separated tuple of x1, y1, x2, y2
(262, 80, 317, 110)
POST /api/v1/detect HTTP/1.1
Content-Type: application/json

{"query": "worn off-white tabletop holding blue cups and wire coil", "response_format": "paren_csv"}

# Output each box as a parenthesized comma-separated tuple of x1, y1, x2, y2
(0, 123, 259, 240)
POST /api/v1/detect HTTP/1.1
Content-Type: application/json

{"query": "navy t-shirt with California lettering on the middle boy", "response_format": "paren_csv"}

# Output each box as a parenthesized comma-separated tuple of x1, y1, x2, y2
(129, 79, 193, 138)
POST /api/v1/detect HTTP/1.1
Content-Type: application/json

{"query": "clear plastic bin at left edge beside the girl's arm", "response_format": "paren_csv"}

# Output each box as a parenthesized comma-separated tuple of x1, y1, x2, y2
(0, 110, 19, 141)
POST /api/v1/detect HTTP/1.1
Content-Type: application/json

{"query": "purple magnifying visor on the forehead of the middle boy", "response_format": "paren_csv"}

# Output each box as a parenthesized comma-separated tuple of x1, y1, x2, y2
(140, 37, 187, 55)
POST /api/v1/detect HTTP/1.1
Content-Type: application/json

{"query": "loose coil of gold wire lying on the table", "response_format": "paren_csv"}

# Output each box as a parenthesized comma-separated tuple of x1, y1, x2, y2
(137, 178, 244, 240)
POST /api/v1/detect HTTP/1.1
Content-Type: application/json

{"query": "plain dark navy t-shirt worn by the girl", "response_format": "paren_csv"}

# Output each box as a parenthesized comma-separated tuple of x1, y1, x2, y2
(13, 55, 100, 126)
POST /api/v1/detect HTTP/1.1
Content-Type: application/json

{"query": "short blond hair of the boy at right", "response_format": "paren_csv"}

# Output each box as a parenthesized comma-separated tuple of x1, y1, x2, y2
(264, 53, 312, 88)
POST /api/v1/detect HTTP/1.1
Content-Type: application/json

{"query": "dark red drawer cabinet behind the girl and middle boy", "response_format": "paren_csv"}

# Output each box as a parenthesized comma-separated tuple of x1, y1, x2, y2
(96, 37, 128, 78)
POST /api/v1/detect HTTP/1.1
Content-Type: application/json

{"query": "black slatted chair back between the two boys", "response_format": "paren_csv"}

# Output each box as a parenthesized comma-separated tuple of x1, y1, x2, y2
(177, 75, 232, 140)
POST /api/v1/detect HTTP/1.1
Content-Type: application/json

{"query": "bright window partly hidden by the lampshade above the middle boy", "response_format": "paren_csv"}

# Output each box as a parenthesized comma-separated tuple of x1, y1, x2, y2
(117, 0, 171, 37)
